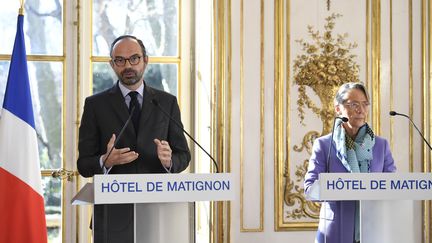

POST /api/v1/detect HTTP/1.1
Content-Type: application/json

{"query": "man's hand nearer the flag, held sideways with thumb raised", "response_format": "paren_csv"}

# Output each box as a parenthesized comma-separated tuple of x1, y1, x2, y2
(102, 134, 138, 168)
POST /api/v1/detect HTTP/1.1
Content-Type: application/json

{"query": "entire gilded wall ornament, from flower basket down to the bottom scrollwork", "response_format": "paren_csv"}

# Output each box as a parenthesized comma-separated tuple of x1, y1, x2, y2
(284, 14, 359, 220)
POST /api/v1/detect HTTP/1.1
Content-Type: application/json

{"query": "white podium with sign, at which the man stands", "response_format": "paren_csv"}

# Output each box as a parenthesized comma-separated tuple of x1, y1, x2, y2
(72, 173, 235, 243)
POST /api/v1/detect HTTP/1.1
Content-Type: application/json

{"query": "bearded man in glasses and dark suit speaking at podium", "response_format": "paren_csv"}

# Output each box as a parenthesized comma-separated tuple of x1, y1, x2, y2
(77, 35, 191, 242)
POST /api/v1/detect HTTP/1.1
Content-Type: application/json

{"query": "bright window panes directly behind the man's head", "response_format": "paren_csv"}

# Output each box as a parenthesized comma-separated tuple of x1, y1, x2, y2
(92, 0, 180, 96)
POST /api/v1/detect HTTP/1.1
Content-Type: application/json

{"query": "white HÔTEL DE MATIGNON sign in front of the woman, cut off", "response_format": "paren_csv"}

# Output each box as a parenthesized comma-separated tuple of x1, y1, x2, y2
(319, 173, 432, 200)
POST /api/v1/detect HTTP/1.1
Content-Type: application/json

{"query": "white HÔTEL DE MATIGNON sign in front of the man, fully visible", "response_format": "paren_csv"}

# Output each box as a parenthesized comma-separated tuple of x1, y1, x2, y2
(94, 173, 235, 204)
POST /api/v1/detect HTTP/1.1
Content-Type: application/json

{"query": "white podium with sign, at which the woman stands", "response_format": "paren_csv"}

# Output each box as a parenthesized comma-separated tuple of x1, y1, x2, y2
(308, 173, 432, 243)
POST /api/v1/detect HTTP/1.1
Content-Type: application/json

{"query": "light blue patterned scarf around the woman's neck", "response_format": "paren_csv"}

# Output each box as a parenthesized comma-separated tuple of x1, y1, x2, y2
(333, 120, 375, 241)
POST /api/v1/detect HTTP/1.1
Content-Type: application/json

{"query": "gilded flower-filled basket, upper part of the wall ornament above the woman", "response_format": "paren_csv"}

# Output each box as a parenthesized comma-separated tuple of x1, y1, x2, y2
(293, 14, 359, 135)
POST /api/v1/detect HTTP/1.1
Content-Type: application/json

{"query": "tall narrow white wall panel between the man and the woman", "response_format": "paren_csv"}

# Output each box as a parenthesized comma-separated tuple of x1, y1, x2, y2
(241, 0, 266, 229)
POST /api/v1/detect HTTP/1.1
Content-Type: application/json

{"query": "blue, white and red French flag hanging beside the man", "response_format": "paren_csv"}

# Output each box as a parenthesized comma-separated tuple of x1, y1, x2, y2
(0, 10, 47, 243)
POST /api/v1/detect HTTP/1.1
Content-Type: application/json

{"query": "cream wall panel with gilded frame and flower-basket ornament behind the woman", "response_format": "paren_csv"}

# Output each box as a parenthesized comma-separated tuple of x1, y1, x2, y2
(275, 1, 368, 230)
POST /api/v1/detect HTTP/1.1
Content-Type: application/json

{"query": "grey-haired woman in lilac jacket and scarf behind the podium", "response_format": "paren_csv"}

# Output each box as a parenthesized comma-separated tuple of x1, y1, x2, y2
(304, 83, 396, 243)
